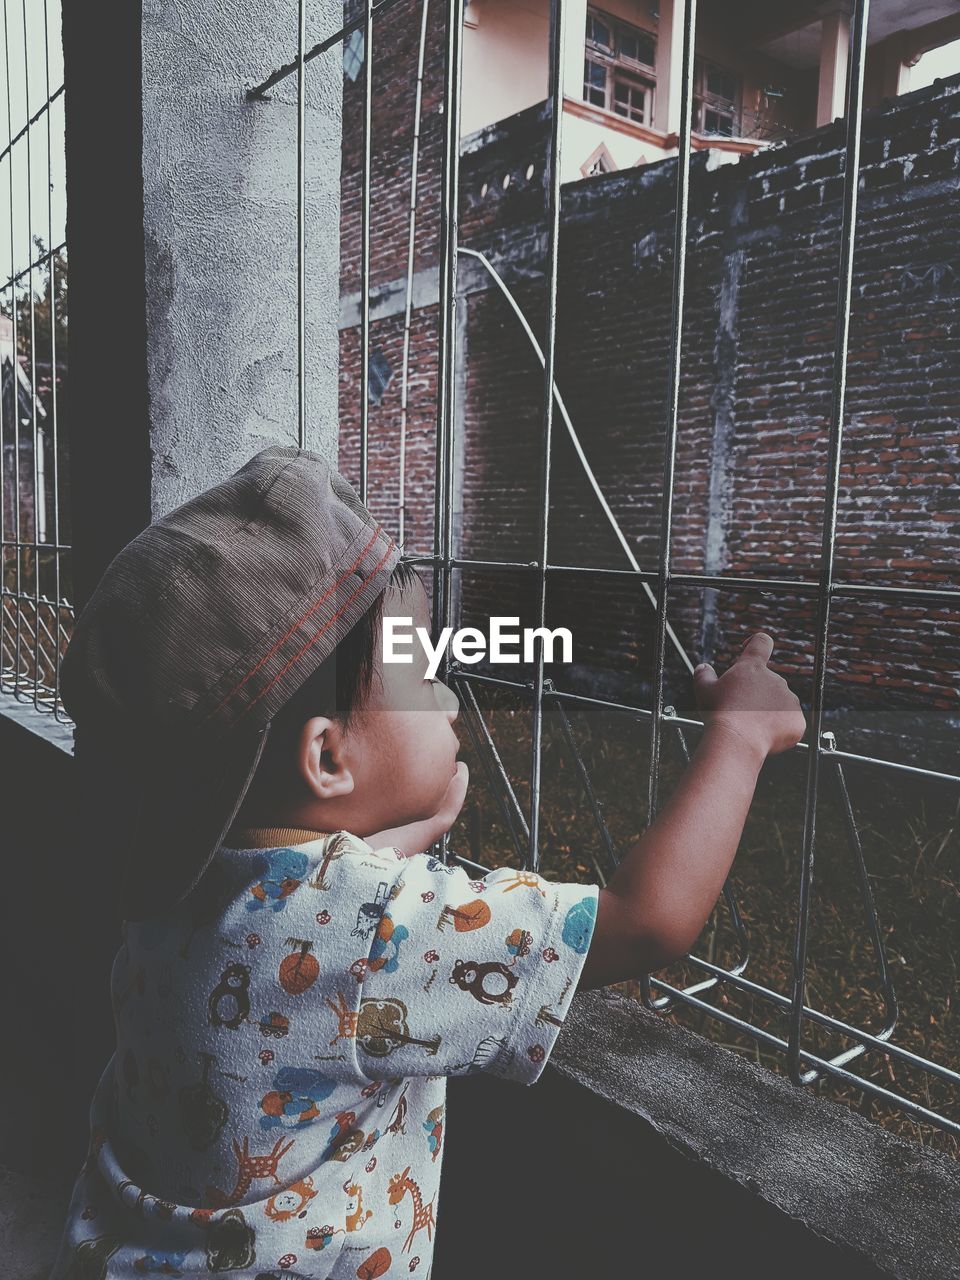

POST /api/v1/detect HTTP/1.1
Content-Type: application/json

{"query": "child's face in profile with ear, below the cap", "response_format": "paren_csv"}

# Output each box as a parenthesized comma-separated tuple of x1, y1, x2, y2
(293, 581, 460, 836)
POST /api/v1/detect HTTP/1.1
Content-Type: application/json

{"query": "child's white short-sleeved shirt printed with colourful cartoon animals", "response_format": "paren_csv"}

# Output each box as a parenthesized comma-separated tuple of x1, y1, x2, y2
(51, 832, 598, 1280)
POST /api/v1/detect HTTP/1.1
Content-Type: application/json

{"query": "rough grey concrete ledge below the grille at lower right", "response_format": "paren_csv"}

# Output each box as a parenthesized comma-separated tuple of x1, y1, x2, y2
(550, 992, 960, 1280)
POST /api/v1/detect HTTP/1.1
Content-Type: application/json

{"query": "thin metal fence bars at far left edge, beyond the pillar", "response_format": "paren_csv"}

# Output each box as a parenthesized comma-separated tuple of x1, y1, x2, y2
(0, 0, 73, 723)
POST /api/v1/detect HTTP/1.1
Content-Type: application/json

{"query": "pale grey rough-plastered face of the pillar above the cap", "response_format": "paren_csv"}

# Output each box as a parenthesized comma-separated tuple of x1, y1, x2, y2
(142, 0, 343, 518)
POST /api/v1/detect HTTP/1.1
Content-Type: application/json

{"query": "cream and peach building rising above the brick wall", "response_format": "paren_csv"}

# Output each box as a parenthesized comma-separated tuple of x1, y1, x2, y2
(463, 0, 960, 180)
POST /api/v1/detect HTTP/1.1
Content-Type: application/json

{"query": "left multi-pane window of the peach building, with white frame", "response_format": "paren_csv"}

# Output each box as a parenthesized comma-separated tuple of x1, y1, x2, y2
(584, 9, 657, 124)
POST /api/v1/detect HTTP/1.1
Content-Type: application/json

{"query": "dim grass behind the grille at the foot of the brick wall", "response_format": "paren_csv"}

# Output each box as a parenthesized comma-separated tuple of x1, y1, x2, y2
(457, 689, 960, 1157)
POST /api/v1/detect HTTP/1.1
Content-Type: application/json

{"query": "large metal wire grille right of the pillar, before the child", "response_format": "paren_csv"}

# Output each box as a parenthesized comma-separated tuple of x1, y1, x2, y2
(250, 0, 960, 1135)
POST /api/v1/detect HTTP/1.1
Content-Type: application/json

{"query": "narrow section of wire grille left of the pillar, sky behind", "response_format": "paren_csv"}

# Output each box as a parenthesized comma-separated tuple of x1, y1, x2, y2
(0, 0, 73, 721)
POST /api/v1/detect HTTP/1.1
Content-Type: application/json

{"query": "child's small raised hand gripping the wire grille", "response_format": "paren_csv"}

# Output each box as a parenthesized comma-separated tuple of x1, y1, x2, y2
(694, 631, 806, 758)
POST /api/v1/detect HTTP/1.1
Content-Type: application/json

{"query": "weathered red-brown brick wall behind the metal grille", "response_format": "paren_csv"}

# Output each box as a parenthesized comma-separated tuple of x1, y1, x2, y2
(342, 24, 960, 737)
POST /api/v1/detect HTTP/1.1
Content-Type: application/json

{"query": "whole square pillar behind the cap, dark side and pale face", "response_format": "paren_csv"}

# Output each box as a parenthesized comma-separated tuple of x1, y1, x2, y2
(63, 0, 343, 604)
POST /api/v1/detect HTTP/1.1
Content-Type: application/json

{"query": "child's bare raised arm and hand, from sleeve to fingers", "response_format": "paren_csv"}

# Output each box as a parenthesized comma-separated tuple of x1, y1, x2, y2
(579, 631, 806, 988)
